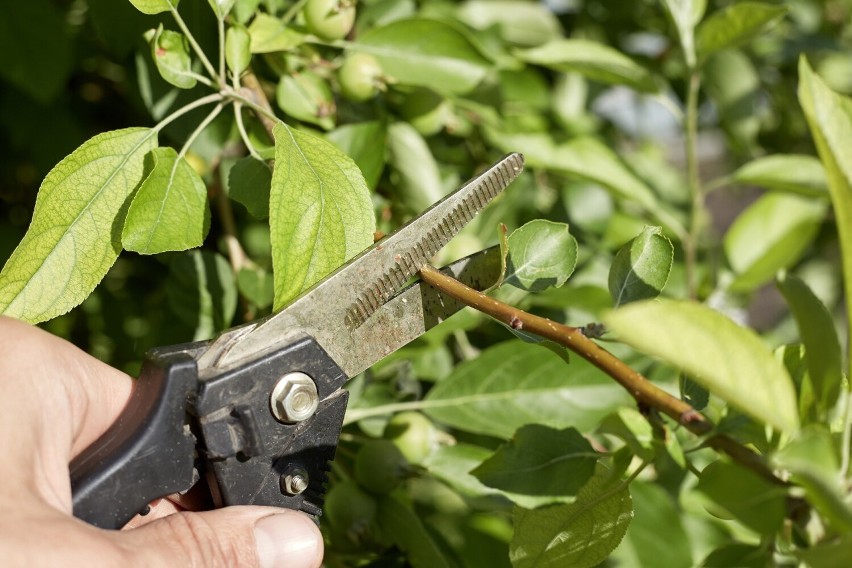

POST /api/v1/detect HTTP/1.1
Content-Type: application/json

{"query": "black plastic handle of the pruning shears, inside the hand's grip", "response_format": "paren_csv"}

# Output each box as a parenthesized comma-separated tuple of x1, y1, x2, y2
(70, 347, 198, 529)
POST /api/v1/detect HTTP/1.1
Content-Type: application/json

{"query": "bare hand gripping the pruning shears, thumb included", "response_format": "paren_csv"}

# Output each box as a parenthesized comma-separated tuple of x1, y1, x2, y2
(0, 317, 323, 568)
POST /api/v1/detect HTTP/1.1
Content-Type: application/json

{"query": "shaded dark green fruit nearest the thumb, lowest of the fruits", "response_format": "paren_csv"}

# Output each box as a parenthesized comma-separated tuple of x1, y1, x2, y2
(325, 479, 377, 545)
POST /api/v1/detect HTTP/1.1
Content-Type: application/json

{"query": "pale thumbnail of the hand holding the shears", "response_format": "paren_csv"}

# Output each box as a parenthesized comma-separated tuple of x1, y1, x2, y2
(254, 511, 322, 568)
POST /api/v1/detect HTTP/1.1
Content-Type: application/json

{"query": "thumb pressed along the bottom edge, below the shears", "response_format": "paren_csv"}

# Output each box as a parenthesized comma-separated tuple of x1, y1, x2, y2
(115, 506, 323, 568)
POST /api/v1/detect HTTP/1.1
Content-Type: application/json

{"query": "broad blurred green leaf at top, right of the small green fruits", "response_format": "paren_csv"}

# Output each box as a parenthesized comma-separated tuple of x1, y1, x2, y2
(350, 18, 490, 93)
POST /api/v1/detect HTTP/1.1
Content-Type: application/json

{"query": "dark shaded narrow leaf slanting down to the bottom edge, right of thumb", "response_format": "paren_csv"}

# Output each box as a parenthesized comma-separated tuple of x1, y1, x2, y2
(376, 496, 450, 568)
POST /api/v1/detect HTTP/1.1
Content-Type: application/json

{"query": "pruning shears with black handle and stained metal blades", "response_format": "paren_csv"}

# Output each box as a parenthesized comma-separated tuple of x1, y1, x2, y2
(70, 153, 523, 529)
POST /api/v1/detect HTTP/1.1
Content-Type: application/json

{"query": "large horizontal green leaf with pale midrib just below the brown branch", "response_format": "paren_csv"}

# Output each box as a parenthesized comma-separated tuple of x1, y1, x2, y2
(423, 341, 628, 439)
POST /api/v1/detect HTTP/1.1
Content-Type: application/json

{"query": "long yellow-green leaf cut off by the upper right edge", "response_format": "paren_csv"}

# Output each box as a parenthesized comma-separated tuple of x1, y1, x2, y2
(799, 57, 852, 382)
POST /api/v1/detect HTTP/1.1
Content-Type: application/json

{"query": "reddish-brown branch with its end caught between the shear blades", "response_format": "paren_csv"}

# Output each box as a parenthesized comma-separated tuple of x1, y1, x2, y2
(420, 265, 786, 485)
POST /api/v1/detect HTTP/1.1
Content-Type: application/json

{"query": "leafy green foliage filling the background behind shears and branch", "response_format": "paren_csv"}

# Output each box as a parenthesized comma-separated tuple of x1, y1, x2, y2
(0, 0, 852, 566)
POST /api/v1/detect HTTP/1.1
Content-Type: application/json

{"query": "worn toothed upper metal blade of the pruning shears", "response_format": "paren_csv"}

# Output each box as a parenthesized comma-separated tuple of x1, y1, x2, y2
(199, 153, 523, 377)
